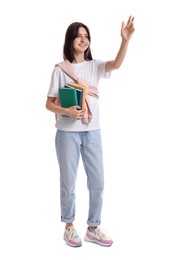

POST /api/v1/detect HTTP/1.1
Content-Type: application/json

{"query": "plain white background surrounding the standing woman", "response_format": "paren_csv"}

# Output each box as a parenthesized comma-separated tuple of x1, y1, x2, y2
(0, 0, 174, 260)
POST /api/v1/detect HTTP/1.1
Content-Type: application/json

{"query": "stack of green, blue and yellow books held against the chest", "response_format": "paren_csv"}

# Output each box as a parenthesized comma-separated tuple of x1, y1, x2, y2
(59, 82, 86, 109)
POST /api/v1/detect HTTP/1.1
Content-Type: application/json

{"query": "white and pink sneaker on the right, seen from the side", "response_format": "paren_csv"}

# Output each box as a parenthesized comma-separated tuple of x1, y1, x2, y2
(84, 227, 113, 246)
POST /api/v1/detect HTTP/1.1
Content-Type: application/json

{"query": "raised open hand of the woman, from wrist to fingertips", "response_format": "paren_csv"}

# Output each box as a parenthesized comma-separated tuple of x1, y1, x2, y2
(121, 16, 135, 41)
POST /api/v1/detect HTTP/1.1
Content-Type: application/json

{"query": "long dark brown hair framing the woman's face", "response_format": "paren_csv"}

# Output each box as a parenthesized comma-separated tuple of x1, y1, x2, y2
(63, 22, 92, 62)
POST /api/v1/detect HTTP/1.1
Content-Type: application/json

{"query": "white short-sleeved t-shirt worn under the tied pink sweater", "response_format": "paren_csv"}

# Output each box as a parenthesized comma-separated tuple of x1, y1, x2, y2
(47, 60, 110, 131)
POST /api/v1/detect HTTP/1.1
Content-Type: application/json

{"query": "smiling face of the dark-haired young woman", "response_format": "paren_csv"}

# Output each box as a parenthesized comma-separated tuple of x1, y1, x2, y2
(73, 27, 89, 55)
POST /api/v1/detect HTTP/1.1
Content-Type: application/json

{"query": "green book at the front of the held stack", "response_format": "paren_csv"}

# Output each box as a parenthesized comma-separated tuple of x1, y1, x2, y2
(59, 87, 78, 108)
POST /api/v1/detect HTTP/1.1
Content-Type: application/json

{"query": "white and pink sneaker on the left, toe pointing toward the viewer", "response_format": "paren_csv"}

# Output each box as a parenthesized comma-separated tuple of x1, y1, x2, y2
(63, 226, 82, 247)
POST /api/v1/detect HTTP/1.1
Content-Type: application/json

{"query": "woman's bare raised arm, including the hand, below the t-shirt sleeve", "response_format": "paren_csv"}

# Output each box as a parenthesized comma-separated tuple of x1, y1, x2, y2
(105, 16, 135, 72)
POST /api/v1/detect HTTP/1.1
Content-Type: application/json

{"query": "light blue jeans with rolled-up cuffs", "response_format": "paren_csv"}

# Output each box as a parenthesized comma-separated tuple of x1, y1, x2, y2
(55, 130, 104, 226)
